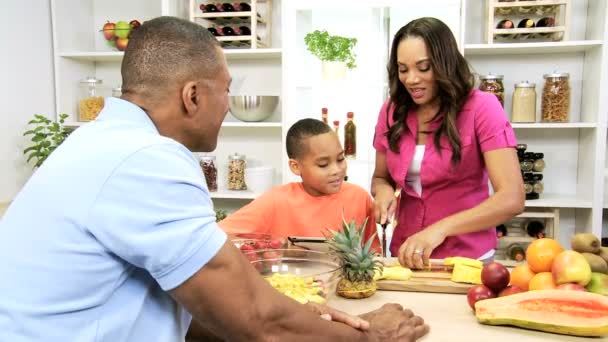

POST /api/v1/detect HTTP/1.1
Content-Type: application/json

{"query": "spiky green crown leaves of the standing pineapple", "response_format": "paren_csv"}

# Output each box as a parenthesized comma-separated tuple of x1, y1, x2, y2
(326, 215, 382, 281)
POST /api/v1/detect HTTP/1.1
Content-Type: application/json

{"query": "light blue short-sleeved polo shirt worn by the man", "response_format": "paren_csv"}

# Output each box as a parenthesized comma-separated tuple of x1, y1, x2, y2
(0, 98, 226, 342)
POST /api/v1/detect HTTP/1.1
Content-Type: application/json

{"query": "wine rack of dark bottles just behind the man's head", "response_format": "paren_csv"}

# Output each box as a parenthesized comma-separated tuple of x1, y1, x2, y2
(189, 0, 272, 49)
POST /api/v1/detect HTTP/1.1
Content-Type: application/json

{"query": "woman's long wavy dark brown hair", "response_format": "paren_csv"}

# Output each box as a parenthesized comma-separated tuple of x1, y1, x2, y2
(387, 18, 475, 164)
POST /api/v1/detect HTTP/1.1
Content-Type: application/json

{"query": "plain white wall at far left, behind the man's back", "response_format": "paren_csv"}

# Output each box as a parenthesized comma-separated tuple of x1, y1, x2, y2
(0, 0, 55, 202)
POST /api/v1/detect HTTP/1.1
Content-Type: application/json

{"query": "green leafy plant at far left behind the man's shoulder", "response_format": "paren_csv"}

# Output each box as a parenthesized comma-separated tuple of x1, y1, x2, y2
(23, 114, 70, 167)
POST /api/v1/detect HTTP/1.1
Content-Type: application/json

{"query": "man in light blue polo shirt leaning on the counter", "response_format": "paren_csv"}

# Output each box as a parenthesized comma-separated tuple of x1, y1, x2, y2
(0, 17, 428, 342)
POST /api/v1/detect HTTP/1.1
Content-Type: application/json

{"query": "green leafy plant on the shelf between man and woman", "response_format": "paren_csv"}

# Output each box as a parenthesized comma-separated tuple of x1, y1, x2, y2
(304, 30, 357, 69)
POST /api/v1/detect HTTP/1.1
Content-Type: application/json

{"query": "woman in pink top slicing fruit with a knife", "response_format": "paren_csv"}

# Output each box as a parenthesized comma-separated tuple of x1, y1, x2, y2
(372, 18, 525, 268)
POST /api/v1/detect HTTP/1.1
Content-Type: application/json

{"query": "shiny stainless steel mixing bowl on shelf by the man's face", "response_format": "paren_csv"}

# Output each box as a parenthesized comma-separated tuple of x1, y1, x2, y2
(230, 95, 279, 122)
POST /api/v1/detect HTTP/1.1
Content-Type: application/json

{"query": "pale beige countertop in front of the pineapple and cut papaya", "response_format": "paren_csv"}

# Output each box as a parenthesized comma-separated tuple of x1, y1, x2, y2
(328, 291, 608, 342)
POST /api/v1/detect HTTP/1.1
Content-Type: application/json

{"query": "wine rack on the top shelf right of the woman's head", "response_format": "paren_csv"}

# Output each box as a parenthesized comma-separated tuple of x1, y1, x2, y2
(486, 0, 571, 44)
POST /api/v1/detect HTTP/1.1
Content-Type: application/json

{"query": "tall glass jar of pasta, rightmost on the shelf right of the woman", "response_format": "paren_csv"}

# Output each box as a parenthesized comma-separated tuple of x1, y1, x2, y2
(541, 72, 570, 122)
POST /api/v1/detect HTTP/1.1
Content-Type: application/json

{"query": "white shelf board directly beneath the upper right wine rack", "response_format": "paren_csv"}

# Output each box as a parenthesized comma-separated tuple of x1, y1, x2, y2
(464, 40, 602, 56)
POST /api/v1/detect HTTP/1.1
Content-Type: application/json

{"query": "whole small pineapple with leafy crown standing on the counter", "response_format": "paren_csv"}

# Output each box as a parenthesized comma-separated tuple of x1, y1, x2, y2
(327, 217, 382, 299)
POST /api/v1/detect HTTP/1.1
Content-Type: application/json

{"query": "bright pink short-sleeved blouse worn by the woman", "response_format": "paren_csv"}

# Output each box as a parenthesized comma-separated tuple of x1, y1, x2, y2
(374, 90, 517, 259)
